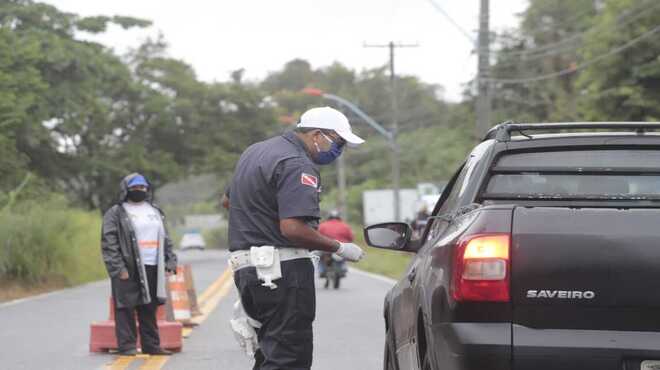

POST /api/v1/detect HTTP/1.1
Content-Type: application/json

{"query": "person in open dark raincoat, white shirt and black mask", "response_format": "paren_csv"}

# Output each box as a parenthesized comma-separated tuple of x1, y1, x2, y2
(101, 173, 177, 356)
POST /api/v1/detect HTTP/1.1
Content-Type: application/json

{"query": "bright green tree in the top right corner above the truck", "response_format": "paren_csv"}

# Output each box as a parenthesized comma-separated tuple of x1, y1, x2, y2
(577, 0, 660, 121)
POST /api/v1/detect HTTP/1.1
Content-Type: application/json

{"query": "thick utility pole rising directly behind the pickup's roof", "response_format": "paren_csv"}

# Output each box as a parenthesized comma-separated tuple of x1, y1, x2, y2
(475, 0, 491, 141)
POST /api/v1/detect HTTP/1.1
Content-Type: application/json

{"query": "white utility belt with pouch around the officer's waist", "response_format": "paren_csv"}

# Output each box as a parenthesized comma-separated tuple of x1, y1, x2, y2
(228, 245, 312, 289)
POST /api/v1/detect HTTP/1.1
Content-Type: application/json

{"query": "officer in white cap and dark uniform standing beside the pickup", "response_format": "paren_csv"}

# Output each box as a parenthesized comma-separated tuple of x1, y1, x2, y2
(223, 107, 364, 370)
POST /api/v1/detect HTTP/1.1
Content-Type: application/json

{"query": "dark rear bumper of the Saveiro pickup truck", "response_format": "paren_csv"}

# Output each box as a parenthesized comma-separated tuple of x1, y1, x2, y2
(430, 323, 660, 370)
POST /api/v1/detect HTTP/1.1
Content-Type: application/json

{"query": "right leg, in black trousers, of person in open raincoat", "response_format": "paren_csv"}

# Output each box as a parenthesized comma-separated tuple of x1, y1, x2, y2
(136, 266, 160, 352)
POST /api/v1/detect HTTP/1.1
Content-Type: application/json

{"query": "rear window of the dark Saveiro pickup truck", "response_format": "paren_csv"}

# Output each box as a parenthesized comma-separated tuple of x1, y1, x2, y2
(482, 150, 660, 200)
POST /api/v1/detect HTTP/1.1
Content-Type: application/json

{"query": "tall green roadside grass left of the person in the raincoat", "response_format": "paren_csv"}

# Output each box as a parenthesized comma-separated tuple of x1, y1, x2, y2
(0, 197, 106, 285)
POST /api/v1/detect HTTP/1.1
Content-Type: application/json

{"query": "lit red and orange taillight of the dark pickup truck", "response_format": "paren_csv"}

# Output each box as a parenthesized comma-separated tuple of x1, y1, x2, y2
(451, 234, 511, 302)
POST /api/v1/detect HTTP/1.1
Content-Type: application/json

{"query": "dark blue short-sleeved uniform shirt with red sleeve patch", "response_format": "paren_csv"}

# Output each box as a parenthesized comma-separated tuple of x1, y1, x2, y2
(227, 132, 321, 251)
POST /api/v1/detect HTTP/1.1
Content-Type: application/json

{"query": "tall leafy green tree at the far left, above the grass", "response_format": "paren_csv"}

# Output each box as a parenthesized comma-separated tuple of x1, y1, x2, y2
(0, 0, 153, 207)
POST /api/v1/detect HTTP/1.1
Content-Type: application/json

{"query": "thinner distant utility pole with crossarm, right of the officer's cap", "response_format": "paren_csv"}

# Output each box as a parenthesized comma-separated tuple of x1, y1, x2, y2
(364, 41, 418, 221)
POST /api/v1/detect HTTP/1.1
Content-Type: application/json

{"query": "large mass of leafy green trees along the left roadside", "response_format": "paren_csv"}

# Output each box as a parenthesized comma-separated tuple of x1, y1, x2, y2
(0, 0, 274, 208)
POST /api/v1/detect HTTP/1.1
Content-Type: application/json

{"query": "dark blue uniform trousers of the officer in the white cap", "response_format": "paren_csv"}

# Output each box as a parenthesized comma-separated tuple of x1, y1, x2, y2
(234, 258, 316, 370)
